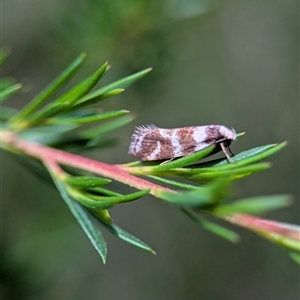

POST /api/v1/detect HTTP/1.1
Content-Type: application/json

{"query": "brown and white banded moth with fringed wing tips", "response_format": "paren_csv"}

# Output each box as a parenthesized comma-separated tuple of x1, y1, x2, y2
(128, 124, 236, 162)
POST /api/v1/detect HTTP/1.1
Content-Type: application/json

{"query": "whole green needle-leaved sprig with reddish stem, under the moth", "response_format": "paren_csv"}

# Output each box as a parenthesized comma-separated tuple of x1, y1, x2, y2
(0, 52, 299, 262)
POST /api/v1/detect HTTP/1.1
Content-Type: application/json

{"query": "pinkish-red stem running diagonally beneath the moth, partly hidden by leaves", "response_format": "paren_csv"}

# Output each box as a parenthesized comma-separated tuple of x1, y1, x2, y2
(1, 132, 300, 244)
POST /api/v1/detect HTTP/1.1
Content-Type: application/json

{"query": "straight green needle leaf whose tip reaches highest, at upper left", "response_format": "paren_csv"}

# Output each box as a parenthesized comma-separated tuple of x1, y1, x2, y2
(11, 53, 86, 123)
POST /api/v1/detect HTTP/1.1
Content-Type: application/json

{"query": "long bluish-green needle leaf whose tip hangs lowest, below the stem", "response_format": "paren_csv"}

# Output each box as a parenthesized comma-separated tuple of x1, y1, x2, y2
(52, 175, 107, 263)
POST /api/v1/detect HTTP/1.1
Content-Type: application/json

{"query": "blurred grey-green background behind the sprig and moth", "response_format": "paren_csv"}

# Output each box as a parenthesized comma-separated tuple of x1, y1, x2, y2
(1, 0, 300, 300)
